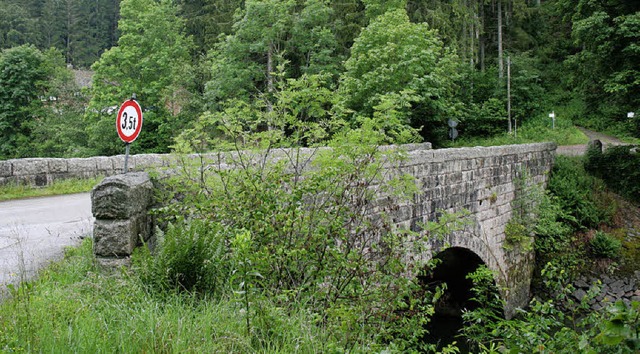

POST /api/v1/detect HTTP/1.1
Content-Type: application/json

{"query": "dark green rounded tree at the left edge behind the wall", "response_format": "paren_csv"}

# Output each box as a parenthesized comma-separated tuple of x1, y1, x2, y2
(0, 45, 50, 158)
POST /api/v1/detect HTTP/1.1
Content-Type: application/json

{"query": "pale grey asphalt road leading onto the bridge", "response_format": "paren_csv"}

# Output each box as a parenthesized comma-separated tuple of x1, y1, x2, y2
(0, 193, 93, 295)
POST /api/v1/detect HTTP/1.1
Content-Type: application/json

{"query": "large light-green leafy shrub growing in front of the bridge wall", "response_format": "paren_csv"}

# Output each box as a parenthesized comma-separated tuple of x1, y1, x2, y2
(149, 94, 470, 350)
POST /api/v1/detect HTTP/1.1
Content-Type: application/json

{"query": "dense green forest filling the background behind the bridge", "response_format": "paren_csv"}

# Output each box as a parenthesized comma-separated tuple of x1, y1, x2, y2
(0, 0, 640, 159)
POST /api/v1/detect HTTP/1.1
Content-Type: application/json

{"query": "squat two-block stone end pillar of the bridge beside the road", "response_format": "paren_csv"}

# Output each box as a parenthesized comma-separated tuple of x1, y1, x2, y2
(91, 172, 153, 265)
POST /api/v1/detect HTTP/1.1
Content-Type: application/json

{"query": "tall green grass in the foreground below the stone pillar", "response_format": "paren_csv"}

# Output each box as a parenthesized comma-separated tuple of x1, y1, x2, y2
(0, 239, 336, 353)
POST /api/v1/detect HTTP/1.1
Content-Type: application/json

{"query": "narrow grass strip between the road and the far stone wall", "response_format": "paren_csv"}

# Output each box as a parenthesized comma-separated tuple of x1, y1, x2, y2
(0, 177, 104, 201)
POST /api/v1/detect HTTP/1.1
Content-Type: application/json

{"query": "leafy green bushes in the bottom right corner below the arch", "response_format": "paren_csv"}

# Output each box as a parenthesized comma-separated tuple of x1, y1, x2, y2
(463, 263, 640, 354)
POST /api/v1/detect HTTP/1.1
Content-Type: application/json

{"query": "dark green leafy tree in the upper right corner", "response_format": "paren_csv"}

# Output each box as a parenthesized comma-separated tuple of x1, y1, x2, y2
(561, 0, 640, 135)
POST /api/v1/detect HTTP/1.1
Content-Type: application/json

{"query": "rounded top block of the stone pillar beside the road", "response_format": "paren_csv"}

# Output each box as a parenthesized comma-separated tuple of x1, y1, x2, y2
(91, 172, 153, 220)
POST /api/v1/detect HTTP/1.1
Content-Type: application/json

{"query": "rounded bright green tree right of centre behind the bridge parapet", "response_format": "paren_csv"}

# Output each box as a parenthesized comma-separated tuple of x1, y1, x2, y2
(340, 9, 456, 141)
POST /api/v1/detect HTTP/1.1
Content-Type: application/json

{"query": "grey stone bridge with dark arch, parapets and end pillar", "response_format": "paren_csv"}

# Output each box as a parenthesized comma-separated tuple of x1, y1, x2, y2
(0, 143, 556, 317)
